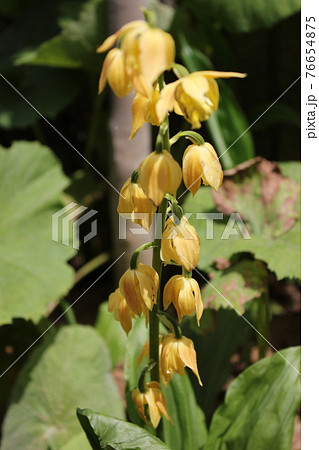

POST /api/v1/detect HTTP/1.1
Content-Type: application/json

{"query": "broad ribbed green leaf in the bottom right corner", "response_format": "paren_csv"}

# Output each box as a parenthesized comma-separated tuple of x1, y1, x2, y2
(205, 347, 300, 450)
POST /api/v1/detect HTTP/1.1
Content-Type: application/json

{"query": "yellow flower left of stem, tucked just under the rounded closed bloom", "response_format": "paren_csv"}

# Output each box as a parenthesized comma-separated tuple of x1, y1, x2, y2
(117, 177, 156, 231)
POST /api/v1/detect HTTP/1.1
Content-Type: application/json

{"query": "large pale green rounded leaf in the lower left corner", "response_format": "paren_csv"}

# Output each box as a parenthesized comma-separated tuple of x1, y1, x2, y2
(2, 325, 124, 450)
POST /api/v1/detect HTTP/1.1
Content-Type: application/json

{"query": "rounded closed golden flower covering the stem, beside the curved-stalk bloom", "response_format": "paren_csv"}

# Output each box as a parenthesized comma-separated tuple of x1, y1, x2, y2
(138, 150, 182, 206)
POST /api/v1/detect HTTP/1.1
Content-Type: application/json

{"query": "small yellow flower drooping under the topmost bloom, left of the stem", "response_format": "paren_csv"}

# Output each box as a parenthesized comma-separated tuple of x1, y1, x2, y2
(130, 88, 161, 139)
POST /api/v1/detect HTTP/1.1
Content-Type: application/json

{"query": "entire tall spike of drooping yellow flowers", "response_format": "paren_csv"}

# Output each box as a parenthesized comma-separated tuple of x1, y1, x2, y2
(101, 14, 245, 428)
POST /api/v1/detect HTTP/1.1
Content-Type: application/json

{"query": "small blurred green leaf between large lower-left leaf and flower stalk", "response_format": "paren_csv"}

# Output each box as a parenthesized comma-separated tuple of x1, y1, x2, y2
(95, 303, 127, 367)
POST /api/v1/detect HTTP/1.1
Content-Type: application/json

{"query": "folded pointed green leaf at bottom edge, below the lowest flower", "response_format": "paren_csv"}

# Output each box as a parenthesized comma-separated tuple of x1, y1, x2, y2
(77, 409, 169, 450)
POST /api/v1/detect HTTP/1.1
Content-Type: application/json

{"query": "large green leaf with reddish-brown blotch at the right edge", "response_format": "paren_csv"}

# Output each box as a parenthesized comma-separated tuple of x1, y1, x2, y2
(183, 159, 300, 279)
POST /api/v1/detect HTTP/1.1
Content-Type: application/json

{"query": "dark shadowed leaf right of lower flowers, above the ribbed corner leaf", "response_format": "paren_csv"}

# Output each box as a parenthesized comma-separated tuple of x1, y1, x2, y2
(183, 309, 252, 417)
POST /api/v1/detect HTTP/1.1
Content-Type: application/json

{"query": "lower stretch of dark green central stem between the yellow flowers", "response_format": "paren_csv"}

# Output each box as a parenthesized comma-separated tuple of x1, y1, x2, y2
(149, 198, 168, 381)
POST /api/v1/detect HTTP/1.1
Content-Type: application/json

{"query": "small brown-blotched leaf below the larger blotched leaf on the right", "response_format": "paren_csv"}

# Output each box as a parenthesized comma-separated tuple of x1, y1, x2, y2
(202, 260, 268, 314)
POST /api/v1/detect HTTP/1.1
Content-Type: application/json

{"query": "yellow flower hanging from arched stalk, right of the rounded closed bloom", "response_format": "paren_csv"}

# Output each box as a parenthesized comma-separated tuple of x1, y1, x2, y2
(183, 142, 223, 196)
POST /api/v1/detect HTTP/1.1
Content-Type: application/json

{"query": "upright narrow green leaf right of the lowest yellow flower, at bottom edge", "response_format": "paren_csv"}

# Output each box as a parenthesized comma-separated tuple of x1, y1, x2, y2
(162, 373, 207, 450)
